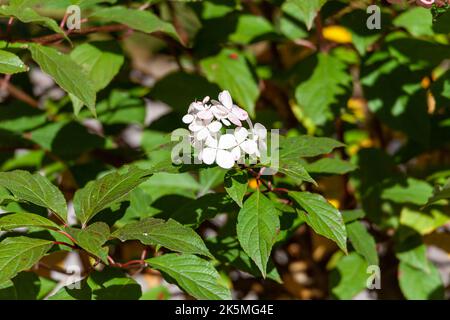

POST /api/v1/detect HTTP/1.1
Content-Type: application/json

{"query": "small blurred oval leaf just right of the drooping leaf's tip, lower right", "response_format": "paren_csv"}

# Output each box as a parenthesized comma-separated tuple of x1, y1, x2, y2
(345, 221, 379, 265)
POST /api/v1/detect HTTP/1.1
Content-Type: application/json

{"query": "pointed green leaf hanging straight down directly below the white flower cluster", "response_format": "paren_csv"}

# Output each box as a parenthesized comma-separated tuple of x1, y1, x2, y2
(236, 191, 280, 277)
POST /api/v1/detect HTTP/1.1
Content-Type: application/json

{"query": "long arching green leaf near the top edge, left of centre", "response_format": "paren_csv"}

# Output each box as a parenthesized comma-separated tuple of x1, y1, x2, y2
(90, 6, 179, 40)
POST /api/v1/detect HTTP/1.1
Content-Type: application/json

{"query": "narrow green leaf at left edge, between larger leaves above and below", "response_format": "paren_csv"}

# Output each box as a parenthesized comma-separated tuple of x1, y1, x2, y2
(0, 212, 59, 231)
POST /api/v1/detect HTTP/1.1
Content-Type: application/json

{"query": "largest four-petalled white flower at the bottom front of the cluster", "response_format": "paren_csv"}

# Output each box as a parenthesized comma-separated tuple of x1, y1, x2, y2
(199, 134, 237, 169)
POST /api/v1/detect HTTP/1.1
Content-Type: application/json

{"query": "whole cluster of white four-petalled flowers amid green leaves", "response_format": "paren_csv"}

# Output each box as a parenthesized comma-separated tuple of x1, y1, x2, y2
(183, 90, 267, 169)
